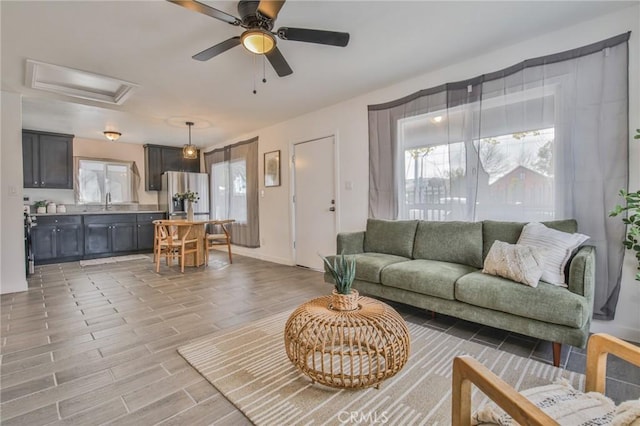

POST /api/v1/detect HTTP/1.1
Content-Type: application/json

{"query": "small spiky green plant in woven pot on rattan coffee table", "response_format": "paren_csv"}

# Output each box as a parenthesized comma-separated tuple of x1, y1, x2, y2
(320, 252, 359, 311)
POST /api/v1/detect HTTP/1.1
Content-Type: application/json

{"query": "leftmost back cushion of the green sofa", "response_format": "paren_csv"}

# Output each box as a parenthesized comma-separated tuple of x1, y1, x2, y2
(364, 219, 418, 258)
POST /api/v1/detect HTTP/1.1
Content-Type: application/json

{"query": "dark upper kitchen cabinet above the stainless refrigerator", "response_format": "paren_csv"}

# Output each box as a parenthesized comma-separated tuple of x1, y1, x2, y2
(144, 144, 200, 191)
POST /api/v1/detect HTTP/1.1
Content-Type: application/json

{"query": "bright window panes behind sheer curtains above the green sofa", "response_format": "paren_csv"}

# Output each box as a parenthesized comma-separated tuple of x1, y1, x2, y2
(399, 123, 555, 221)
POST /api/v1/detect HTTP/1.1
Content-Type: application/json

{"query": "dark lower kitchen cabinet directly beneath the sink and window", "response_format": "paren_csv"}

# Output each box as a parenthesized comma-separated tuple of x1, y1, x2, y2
(84, 214, 138, 255)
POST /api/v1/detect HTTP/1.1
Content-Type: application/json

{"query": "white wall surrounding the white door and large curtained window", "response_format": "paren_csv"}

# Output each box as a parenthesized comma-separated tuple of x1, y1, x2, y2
(206, 5, 640, 341)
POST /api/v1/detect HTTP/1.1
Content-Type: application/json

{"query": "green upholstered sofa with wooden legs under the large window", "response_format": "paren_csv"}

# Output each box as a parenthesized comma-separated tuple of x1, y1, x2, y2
(325, 219, 595, 366)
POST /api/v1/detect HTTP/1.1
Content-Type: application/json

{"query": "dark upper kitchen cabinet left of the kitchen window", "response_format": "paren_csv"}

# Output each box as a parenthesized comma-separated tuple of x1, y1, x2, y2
(22, 130, 73, 189)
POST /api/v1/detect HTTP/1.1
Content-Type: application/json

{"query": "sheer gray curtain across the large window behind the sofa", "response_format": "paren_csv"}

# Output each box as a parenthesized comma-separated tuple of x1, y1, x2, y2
(369, 33, 629, 319)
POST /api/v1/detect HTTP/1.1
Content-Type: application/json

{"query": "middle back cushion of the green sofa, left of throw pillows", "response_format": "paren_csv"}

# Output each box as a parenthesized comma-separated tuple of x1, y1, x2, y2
(413, 221, 482, 268)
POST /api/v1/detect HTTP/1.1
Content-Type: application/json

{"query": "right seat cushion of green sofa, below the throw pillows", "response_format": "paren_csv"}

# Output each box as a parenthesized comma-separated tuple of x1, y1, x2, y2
(455, 271, 591, 328)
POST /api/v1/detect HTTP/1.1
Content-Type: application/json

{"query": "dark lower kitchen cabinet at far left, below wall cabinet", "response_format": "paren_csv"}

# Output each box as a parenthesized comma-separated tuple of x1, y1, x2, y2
(31, 215, 84, 264)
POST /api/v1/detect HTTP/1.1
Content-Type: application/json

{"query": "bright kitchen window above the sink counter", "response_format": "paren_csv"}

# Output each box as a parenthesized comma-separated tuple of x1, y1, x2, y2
(77, 159, 134, 204)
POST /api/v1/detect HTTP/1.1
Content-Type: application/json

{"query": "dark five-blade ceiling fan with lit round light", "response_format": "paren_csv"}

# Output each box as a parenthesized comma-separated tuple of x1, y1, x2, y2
(168, 0, 349, 77)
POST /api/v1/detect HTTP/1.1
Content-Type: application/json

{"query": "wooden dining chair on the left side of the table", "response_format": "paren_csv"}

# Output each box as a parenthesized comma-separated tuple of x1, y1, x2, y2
(153, 220, 200, 272)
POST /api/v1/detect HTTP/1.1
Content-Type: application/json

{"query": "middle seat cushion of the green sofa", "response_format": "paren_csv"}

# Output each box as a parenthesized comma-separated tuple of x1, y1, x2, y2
(382, 259, 477, 300)
